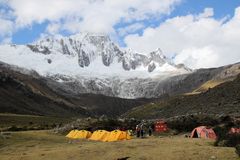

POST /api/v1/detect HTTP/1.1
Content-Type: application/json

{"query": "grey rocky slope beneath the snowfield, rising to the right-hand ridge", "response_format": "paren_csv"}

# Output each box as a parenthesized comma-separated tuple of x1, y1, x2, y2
(44, 63, 240, 98)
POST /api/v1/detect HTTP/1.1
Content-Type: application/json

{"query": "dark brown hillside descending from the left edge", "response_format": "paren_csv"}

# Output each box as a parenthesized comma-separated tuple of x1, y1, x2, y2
(0, 64, 86, 116)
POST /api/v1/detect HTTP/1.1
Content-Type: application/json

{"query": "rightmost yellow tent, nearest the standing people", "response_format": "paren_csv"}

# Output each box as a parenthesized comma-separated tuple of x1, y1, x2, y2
(106, 130, 131, 142)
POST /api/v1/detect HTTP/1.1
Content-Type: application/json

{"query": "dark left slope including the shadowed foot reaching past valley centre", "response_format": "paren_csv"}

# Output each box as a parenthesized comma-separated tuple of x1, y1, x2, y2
(0, 63, 152, 117)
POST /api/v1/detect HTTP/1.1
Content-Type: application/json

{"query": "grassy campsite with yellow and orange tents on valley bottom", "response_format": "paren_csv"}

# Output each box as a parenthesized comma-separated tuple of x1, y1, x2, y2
(0, 115, 239, 160)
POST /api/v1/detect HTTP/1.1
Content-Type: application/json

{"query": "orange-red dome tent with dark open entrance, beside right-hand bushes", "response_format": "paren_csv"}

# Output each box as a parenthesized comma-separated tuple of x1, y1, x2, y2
(191, 126, 217, 139)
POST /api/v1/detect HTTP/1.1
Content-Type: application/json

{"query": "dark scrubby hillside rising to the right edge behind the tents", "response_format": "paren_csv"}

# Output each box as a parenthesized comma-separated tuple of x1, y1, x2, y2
(123, 76, 240, 119)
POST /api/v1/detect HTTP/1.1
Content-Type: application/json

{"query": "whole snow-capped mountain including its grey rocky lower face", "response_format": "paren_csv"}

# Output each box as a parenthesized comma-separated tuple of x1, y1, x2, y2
(0, 33, 191, 98)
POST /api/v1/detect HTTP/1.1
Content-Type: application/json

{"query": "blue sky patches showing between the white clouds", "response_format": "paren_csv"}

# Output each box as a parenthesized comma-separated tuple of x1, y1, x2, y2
(5, 0, 240, 46)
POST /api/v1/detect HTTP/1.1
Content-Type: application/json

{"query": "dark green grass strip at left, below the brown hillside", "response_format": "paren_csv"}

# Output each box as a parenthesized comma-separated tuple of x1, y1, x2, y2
(0, 113, 74, 131)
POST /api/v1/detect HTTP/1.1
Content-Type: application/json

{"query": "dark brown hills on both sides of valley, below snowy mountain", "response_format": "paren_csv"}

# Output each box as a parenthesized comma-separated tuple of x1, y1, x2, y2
(0, 60, 240, 118)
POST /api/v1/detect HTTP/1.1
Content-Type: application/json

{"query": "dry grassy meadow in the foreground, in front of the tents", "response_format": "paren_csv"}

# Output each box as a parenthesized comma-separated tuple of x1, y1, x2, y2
(0, 131, 238, 160)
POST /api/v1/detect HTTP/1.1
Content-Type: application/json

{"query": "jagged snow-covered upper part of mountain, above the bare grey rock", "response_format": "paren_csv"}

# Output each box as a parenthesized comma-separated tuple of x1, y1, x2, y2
(0, 32, 189, 78)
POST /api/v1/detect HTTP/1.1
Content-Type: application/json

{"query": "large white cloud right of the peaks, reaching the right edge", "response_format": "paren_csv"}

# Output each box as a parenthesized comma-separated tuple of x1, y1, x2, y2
(125, 7, 240, 68)
